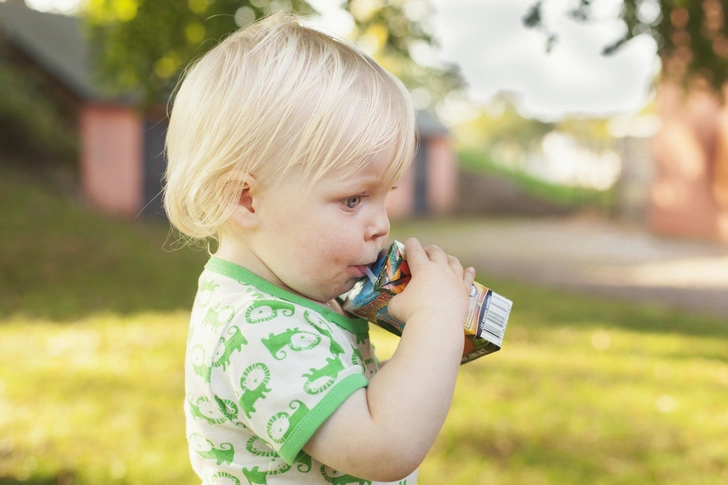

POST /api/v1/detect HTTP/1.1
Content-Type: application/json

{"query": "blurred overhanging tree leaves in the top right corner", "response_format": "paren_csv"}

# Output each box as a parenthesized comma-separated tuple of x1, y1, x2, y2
(523, 0, 728, 92)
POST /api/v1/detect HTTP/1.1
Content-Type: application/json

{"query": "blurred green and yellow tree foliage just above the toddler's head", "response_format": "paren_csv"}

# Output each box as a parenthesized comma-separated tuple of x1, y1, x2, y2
(86, 0, 462, 104)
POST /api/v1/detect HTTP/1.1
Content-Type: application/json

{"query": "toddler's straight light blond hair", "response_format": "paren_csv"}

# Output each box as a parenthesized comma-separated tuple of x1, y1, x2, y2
(164, 14, 415, 239)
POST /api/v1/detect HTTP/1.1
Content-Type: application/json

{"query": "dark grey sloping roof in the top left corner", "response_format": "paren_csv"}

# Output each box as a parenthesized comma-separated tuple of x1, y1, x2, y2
(0, 2, 108, 99)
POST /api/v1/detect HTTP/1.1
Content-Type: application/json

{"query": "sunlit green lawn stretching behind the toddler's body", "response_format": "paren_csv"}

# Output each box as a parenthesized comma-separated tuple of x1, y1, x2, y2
(0, 164, 728, 485)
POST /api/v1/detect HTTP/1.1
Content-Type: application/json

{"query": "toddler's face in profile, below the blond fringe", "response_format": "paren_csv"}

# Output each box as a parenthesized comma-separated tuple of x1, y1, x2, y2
(249, 144, 393, 302)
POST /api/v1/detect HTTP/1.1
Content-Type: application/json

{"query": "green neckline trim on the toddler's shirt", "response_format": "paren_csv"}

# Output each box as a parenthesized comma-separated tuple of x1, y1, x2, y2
(205, 256, 369, 334)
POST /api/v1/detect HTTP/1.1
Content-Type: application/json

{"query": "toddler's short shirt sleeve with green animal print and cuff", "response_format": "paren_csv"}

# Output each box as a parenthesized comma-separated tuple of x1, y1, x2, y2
(211, 299, 367, 464)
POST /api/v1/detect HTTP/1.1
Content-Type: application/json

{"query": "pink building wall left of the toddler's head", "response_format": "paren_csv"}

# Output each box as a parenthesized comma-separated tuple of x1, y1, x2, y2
(79, 104, 144, 217)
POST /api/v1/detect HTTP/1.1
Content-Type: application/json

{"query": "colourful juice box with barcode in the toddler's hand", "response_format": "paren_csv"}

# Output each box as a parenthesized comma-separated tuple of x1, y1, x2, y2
(343, 241, 513, 364)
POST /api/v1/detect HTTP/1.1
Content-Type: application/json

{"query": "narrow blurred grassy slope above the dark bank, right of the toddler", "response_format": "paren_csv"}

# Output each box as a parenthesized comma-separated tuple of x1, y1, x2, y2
(458, 149, 615, 211)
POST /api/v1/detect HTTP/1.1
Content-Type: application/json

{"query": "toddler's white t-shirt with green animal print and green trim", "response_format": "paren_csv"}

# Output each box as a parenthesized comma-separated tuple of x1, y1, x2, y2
(185, 257, 417, 485)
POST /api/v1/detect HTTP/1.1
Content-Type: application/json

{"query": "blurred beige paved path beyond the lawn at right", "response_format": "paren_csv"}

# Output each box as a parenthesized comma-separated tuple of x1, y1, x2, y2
(394, 217, 728, 321)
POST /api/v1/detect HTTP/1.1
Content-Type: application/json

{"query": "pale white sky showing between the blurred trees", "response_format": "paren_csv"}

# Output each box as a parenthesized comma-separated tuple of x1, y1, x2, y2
(21, 0, 659, 119)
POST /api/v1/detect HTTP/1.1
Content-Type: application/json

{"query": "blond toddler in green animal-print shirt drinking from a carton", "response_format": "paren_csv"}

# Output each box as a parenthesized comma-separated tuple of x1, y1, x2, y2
(164, 14, 475, 485)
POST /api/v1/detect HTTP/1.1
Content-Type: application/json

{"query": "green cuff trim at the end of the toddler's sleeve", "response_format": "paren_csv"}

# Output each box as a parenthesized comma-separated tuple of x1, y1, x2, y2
(278, 374, 369, 465)
